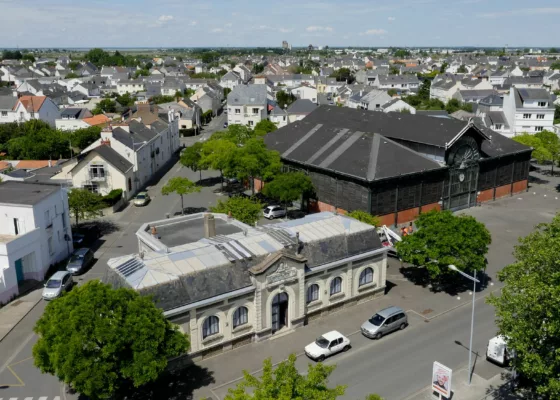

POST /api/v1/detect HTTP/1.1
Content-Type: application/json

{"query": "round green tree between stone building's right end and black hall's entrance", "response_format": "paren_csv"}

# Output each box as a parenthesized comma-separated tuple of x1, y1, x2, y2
(396, 210, 492, 280)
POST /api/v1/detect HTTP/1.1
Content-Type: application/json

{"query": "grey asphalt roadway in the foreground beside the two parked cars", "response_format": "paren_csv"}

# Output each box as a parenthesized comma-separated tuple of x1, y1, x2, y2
(213, 297, 502, 400)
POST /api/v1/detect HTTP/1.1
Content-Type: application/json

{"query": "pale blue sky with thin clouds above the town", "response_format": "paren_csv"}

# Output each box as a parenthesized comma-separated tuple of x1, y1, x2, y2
(0, 0, 560, 47)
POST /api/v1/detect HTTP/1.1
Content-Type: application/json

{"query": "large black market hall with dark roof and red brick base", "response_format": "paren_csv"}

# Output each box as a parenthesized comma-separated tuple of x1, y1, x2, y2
(264, 106, 531, 225)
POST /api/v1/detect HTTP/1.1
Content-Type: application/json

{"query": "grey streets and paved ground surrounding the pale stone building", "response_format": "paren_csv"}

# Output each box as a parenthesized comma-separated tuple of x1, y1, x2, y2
(0, 148, 559, 400)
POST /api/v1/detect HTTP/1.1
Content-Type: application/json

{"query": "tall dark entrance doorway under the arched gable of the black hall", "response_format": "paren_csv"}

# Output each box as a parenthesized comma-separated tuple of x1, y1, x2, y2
(443, 162, 478, 211)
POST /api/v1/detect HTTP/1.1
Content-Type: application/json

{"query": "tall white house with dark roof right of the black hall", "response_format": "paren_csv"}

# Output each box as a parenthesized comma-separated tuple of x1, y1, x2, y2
(504, 87, 554, 136)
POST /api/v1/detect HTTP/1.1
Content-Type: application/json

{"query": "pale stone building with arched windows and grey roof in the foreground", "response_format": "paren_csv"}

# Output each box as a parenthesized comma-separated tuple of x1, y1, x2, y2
(104, 212, 387, 358)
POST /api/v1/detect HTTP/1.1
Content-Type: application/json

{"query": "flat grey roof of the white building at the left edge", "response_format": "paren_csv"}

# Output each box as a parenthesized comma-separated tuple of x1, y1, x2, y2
(0, 181, 61, 206)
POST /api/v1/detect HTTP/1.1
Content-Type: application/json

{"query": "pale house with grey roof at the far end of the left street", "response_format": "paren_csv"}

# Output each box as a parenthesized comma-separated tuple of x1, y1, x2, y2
(227, 85, 268, 126)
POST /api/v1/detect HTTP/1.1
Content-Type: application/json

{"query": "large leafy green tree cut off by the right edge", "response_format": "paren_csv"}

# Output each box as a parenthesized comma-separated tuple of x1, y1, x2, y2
(488, 214, 560, 399)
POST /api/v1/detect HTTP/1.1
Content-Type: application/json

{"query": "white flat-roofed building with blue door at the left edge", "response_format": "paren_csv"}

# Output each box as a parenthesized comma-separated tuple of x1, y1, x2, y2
(0, 181, 73, 303)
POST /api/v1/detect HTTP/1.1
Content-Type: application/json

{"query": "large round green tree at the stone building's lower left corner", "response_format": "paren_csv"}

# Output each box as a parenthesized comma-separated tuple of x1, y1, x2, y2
(33, 280, 189, 400)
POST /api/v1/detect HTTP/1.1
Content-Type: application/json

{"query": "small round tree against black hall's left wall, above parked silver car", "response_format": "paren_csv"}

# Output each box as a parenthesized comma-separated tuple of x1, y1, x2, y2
(262, 172, 314, 211)
